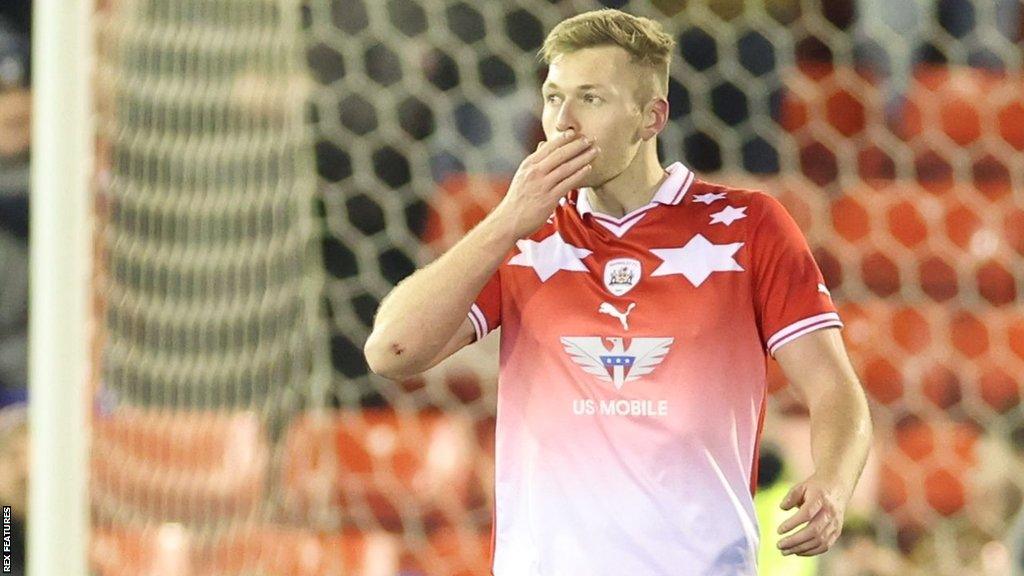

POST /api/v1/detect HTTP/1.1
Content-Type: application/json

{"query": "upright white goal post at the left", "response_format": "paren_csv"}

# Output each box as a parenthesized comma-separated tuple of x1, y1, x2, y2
(27, 0, 93, 576)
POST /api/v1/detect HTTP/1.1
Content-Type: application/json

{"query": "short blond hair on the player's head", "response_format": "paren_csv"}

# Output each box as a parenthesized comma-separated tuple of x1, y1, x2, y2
(539, 8, 676, 100)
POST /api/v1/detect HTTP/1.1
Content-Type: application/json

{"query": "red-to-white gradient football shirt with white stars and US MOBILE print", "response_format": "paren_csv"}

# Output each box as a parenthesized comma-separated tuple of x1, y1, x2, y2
(469, 163, 842, 576)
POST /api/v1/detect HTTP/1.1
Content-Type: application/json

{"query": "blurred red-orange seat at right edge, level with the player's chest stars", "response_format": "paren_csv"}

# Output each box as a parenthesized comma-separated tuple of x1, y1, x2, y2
(821, 180, 1024, 306)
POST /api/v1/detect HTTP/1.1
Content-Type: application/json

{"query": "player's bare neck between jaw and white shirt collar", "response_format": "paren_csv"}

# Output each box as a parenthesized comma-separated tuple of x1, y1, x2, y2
(589, 140, 667, 218)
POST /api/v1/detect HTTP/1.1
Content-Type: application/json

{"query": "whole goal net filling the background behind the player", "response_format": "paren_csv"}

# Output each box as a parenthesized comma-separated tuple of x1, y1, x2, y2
(93, 0, 1024, 575)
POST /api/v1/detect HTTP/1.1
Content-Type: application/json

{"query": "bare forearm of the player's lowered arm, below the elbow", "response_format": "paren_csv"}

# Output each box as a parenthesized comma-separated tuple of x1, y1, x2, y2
(810, 380, 871, 500)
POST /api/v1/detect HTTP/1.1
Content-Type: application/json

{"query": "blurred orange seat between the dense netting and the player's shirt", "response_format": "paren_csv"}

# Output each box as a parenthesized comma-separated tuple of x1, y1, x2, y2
(283, 409, 489, 531)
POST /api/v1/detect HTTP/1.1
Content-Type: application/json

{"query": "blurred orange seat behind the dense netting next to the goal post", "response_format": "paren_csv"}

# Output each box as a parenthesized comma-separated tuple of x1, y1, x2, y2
(90, 407, 268, 523)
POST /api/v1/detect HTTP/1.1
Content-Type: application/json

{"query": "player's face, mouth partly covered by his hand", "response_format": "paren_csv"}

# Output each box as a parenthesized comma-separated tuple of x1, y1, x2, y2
(542, 46, 643, 187)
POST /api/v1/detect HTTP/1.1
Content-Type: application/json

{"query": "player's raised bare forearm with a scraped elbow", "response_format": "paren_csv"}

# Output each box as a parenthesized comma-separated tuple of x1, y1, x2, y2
(365, 211, 515, 375)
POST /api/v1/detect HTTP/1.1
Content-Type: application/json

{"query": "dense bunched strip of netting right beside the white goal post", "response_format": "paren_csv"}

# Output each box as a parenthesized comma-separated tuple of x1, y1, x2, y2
(90, 0, 330, 574)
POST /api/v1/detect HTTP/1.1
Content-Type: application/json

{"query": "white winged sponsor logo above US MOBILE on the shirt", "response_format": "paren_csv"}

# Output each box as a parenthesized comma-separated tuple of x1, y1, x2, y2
(561, 336, 675, 389)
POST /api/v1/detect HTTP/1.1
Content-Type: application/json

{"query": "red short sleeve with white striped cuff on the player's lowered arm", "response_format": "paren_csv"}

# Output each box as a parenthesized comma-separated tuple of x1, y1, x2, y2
(752, 195, 843, 357)
